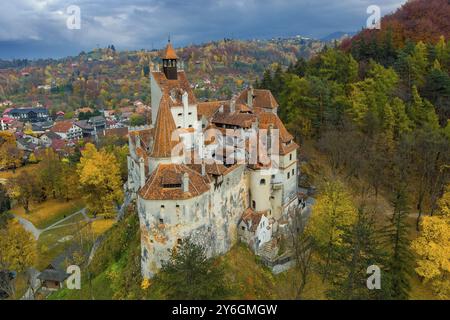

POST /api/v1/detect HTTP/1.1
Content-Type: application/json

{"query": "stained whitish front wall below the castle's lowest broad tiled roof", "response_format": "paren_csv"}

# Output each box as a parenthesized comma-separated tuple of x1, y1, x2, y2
(138, 166, 248, 278)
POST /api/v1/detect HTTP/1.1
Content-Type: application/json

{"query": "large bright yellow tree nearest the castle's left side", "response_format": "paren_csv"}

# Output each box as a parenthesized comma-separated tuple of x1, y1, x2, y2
(77, 143, 123, 216)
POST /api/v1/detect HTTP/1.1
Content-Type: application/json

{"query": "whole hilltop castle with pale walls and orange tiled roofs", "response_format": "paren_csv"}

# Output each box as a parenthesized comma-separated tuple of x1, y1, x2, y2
(126, 42, 299, 278)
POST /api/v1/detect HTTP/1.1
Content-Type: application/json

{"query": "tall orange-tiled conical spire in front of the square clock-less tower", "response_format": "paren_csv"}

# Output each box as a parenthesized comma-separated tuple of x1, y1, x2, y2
(151, 93, 178, 158)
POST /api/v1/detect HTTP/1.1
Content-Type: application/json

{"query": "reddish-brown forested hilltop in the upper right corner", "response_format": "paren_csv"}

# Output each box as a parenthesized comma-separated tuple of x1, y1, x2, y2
(342, 0, 450, 50)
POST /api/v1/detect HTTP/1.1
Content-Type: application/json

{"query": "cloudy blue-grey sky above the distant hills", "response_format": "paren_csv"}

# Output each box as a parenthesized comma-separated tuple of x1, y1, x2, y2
(0, 0, 405, 59)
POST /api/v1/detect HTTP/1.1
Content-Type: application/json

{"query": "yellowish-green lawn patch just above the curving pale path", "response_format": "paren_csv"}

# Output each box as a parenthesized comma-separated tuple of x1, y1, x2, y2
(11, 200, 84, 229)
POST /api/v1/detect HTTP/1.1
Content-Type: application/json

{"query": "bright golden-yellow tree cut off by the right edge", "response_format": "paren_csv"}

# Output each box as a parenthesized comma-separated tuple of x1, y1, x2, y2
(411, 185, 450, 299)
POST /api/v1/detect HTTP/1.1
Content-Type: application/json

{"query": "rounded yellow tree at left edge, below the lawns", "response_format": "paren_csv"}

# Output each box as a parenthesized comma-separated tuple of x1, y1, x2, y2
(0, 220, 36, 272)
